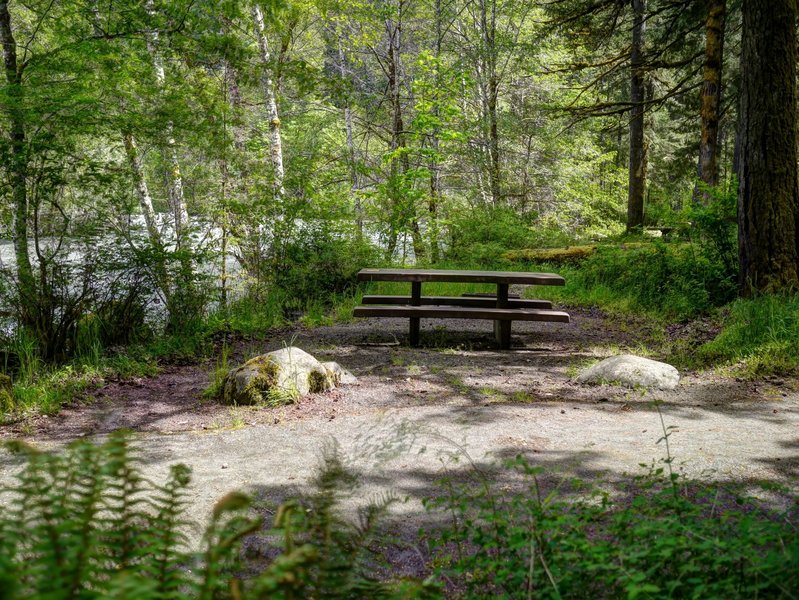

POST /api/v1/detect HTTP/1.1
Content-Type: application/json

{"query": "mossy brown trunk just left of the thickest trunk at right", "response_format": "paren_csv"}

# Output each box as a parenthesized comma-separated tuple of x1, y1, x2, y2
(694, 0, 727, 204)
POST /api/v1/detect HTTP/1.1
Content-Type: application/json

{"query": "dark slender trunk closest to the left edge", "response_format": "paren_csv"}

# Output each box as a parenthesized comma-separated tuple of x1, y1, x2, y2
(0, 0, 36, 304)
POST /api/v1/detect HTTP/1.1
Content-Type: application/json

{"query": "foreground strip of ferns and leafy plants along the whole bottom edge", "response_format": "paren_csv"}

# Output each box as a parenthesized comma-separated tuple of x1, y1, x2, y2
(0, 426, 799, 600)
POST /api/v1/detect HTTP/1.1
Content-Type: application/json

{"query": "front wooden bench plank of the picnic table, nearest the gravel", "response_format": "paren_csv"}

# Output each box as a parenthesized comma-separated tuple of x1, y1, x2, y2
(352, 306, 570, 323)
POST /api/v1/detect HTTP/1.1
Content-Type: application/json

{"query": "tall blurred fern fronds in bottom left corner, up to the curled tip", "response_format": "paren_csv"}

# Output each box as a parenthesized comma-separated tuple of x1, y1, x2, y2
(0, 433, 259, 599)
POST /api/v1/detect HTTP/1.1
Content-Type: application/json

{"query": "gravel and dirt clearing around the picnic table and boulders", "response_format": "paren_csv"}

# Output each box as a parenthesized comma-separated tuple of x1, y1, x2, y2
(0, 308, 799, 560)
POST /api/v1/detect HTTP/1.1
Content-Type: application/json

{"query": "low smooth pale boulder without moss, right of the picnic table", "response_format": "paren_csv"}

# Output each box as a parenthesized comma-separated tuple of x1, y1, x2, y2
(577, 354, 680, 390)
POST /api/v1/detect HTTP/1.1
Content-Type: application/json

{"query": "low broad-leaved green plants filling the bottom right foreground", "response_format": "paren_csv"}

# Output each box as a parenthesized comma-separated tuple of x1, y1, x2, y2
(427, 457, 799, 599)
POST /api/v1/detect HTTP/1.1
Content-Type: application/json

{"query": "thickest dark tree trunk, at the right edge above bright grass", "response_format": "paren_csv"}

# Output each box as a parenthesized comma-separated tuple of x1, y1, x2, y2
(738, 0, 799, 295)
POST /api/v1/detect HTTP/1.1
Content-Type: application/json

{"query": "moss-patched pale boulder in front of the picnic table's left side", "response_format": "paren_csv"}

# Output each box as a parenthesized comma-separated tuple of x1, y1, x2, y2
(222, 346, 355, 405)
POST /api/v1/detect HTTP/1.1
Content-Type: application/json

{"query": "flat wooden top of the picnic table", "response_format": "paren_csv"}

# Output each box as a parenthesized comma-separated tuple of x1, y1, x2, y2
(358, 269, 566, 285)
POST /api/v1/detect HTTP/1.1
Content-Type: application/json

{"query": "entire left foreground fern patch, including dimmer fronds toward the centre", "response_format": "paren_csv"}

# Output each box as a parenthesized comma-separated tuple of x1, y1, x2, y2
(0, 432, 440, 600)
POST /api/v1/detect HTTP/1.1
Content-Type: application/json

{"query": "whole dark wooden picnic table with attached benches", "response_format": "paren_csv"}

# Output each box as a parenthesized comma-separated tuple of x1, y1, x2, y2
(353, 269, 569, 349)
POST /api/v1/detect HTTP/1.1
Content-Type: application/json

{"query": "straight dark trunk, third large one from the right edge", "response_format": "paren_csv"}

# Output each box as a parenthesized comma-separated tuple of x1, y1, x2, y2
(627, 0, 647, 231)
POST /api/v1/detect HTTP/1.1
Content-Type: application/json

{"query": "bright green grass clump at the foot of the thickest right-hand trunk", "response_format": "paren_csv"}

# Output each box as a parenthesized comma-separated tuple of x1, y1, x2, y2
(697, 295, 799, 376)
